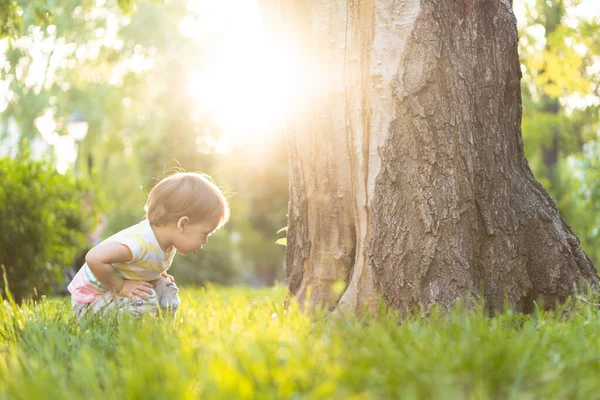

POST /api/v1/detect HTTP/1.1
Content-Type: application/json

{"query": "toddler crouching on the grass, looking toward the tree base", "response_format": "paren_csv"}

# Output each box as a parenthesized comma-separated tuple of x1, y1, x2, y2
(68, 172, 229, 322)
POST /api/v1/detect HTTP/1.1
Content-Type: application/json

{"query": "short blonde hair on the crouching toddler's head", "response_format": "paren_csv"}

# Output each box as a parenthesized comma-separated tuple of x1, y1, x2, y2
(144, 172, 229, 228)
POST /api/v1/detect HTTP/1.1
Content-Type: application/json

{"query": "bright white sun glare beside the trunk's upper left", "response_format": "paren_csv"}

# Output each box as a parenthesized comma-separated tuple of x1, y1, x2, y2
(180, 0, 306, 152)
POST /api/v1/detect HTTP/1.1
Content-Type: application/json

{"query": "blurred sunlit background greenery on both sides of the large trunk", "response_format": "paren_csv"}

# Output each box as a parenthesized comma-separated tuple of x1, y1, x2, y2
(0, 0, 600, 295)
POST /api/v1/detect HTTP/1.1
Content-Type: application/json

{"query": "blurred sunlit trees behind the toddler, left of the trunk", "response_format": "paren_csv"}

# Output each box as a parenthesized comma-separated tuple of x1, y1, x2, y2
(0, 0, 288, 295)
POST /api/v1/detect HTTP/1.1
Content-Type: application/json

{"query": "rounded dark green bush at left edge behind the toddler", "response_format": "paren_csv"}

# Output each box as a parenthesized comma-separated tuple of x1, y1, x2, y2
(0, 152, 93, 301)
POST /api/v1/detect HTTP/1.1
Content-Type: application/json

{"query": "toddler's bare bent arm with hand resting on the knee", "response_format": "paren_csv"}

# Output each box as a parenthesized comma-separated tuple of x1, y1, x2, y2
(85, 242, 152, 301)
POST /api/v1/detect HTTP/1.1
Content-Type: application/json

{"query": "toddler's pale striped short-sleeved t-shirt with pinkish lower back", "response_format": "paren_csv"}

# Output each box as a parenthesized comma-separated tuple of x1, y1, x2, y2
(68, 220, 176, 303)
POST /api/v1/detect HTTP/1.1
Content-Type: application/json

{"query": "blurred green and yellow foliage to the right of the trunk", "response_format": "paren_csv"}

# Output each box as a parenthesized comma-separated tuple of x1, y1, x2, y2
(519, 0, 600, 265)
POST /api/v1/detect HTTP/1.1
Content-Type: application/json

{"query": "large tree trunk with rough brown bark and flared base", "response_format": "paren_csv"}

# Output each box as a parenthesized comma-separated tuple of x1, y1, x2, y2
(263, 0, 598, 312)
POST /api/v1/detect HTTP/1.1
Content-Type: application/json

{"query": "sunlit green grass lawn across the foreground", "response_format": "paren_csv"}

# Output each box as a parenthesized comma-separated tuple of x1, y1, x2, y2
(0, 288, 600, 399)
